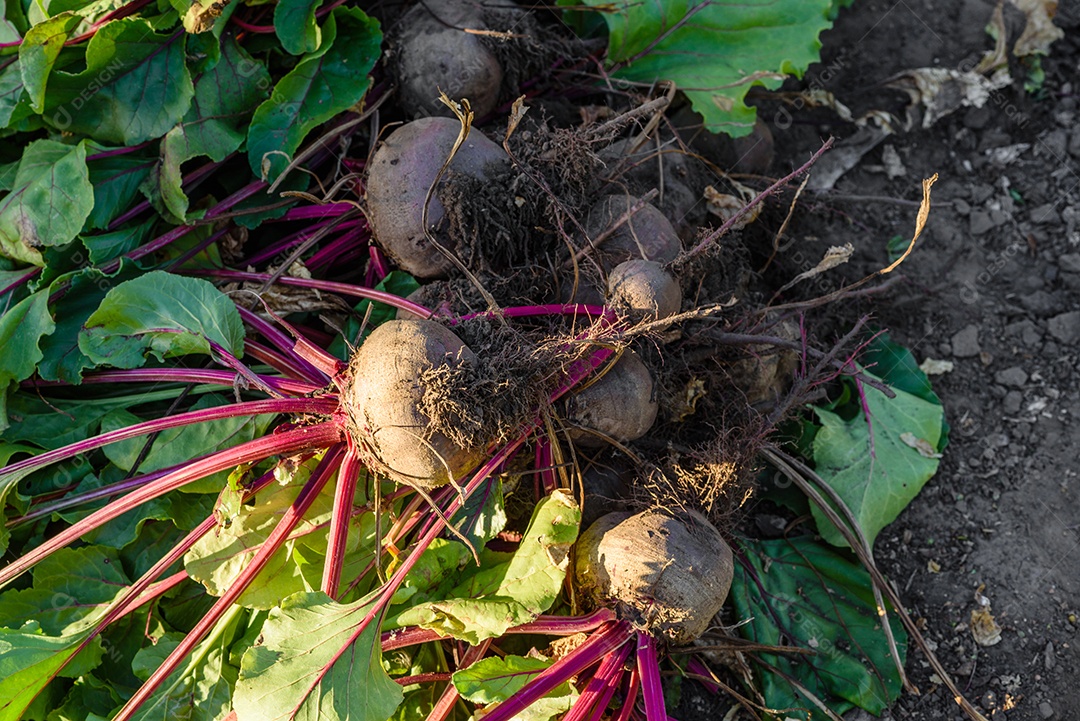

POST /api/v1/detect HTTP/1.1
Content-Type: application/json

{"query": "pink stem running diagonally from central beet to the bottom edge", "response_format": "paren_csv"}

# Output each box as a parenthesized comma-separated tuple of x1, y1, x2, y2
(113, 444, 342, 721)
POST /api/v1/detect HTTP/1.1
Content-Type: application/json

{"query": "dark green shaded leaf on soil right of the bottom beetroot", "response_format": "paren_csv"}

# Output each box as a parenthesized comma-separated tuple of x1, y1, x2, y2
(731, 538, 907, 719)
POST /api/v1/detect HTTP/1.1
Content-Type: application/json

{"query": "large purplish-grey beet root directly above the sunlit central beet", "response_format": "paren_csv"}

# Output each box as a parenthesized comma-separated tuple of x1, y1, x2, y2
(366, 118, 509, 278)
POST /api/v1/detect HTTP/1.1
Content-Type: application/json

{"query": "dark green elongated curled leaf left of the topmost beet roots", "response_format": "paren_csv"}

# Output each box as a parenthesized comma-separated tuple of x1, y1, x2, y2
(247, 8, 382, 180)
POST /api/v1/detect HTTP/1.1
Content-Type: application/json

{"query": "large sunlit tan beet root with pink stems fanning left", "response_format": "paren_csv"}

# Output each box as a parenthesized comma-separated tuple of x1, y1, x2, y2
(345, 321, 484, 490)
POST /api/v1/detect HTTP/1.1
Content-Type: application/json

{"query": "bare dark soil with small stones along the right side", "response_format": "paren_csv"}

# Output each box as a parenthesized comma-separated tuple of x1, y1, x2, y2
(676, 0, 1080, 721)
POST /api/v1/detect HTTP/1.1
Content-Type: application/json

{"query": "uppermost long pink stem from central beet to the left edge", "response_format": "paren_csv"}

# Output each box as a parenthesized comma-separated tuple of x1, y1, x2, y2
(0, 398, 338, 479)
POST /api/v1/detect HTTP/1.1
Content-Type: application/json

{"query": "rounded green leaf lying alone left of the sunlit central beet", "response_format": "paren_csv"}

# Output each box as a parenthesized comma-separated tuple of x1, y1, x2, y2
(79, 271, 244, 368)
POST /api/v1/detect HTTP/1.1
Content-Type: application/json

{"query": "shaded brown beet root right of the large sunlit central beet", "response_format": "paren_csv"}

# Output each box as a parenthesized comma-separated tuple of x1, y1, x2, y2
(566, 350, 659, 447)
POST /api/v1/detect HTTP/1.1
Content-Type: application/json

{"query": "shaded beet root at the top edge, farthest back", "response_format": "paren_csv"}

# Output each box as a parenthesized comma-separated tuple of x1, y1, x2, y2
(394, 0, 502, 118)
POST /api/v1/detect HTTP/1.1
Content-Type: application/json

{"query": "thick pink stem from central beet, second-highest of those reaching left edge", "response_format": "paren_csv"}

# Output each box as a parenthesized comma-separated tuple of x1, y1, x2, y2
(0, 422, 341, 585)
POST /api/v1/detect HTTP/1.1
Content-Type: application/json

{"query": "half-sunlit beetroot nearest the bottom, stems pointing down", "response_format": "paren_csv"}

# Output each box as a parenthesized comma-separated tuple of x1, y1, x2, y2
(575, 511, 734, 644)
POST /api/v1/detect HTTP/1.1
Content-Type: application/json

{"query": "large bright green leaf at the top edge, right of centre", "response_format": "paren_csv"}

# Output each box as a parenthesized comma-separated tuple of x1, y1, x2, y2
(585, 0, 834, 137)
